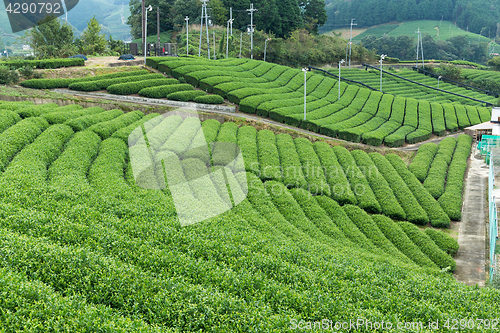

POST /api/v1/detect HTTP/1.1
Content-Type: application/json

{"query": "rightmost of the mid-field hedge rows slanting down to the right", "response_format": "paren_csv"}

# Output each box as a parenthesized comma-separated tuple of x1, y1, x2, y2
(385, 154, 450, 228)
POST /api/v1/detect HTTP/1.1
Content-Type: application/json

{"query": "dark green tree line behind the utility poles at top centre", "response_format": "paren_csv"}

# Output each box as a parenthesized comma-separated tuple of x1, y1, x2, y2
(127, 0, 327, 38)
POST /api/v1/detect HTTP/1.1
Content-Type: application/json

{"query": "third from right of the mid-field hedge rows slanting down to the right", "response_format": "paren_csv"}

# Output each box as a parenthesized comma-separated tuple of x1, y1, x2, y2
(351, 150, 406, 220)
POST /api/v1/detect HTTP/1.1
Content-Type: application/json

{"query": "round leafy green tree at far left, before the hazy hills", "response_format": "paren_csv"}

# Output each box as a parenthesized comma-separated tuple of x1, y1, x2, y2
(21, 16, 76, 58)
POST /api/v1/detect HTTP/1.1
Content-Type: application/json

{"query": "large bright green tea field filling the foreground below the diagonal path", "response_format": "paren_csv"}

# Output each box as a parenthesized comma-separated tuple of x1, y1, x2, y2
(0, 98, 500, 332)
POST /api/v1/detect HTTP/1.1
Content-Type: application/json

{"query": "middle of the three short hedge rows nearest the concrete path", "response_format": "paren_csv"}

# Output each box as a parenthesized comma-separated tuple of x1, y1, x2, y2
(424, 137, 457, 199)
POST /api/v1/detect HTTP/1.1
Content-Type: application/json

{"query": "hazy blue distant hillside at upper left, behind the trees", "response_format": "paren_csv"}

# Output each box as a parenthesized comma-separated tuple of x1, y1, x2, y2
(0, 0, 131, 43)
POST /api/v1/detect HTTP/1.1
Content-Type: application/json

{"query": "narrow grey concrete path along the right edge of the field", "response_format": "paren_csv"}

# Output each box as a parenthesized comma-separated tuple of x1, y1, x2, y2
(454, 146, 488, 287)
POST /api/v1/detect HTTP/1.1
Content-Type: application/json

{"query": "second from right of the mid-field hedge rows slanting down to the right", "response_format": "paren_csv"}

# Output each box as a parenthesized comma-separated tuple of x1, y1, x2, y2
(369, 153, 429, 224)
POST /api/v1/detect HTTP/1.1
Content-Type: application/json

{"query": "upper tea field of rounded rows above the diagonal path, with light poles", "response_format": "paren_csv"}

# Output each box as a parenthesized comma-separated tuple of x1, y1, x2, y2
(149, 58, 491, 147)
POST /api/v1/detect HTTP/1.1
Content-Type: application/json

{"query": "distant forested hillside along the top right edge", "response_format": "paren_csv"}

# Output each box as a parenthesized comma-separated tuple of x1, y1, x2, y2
(322, 0, 500, 38)
